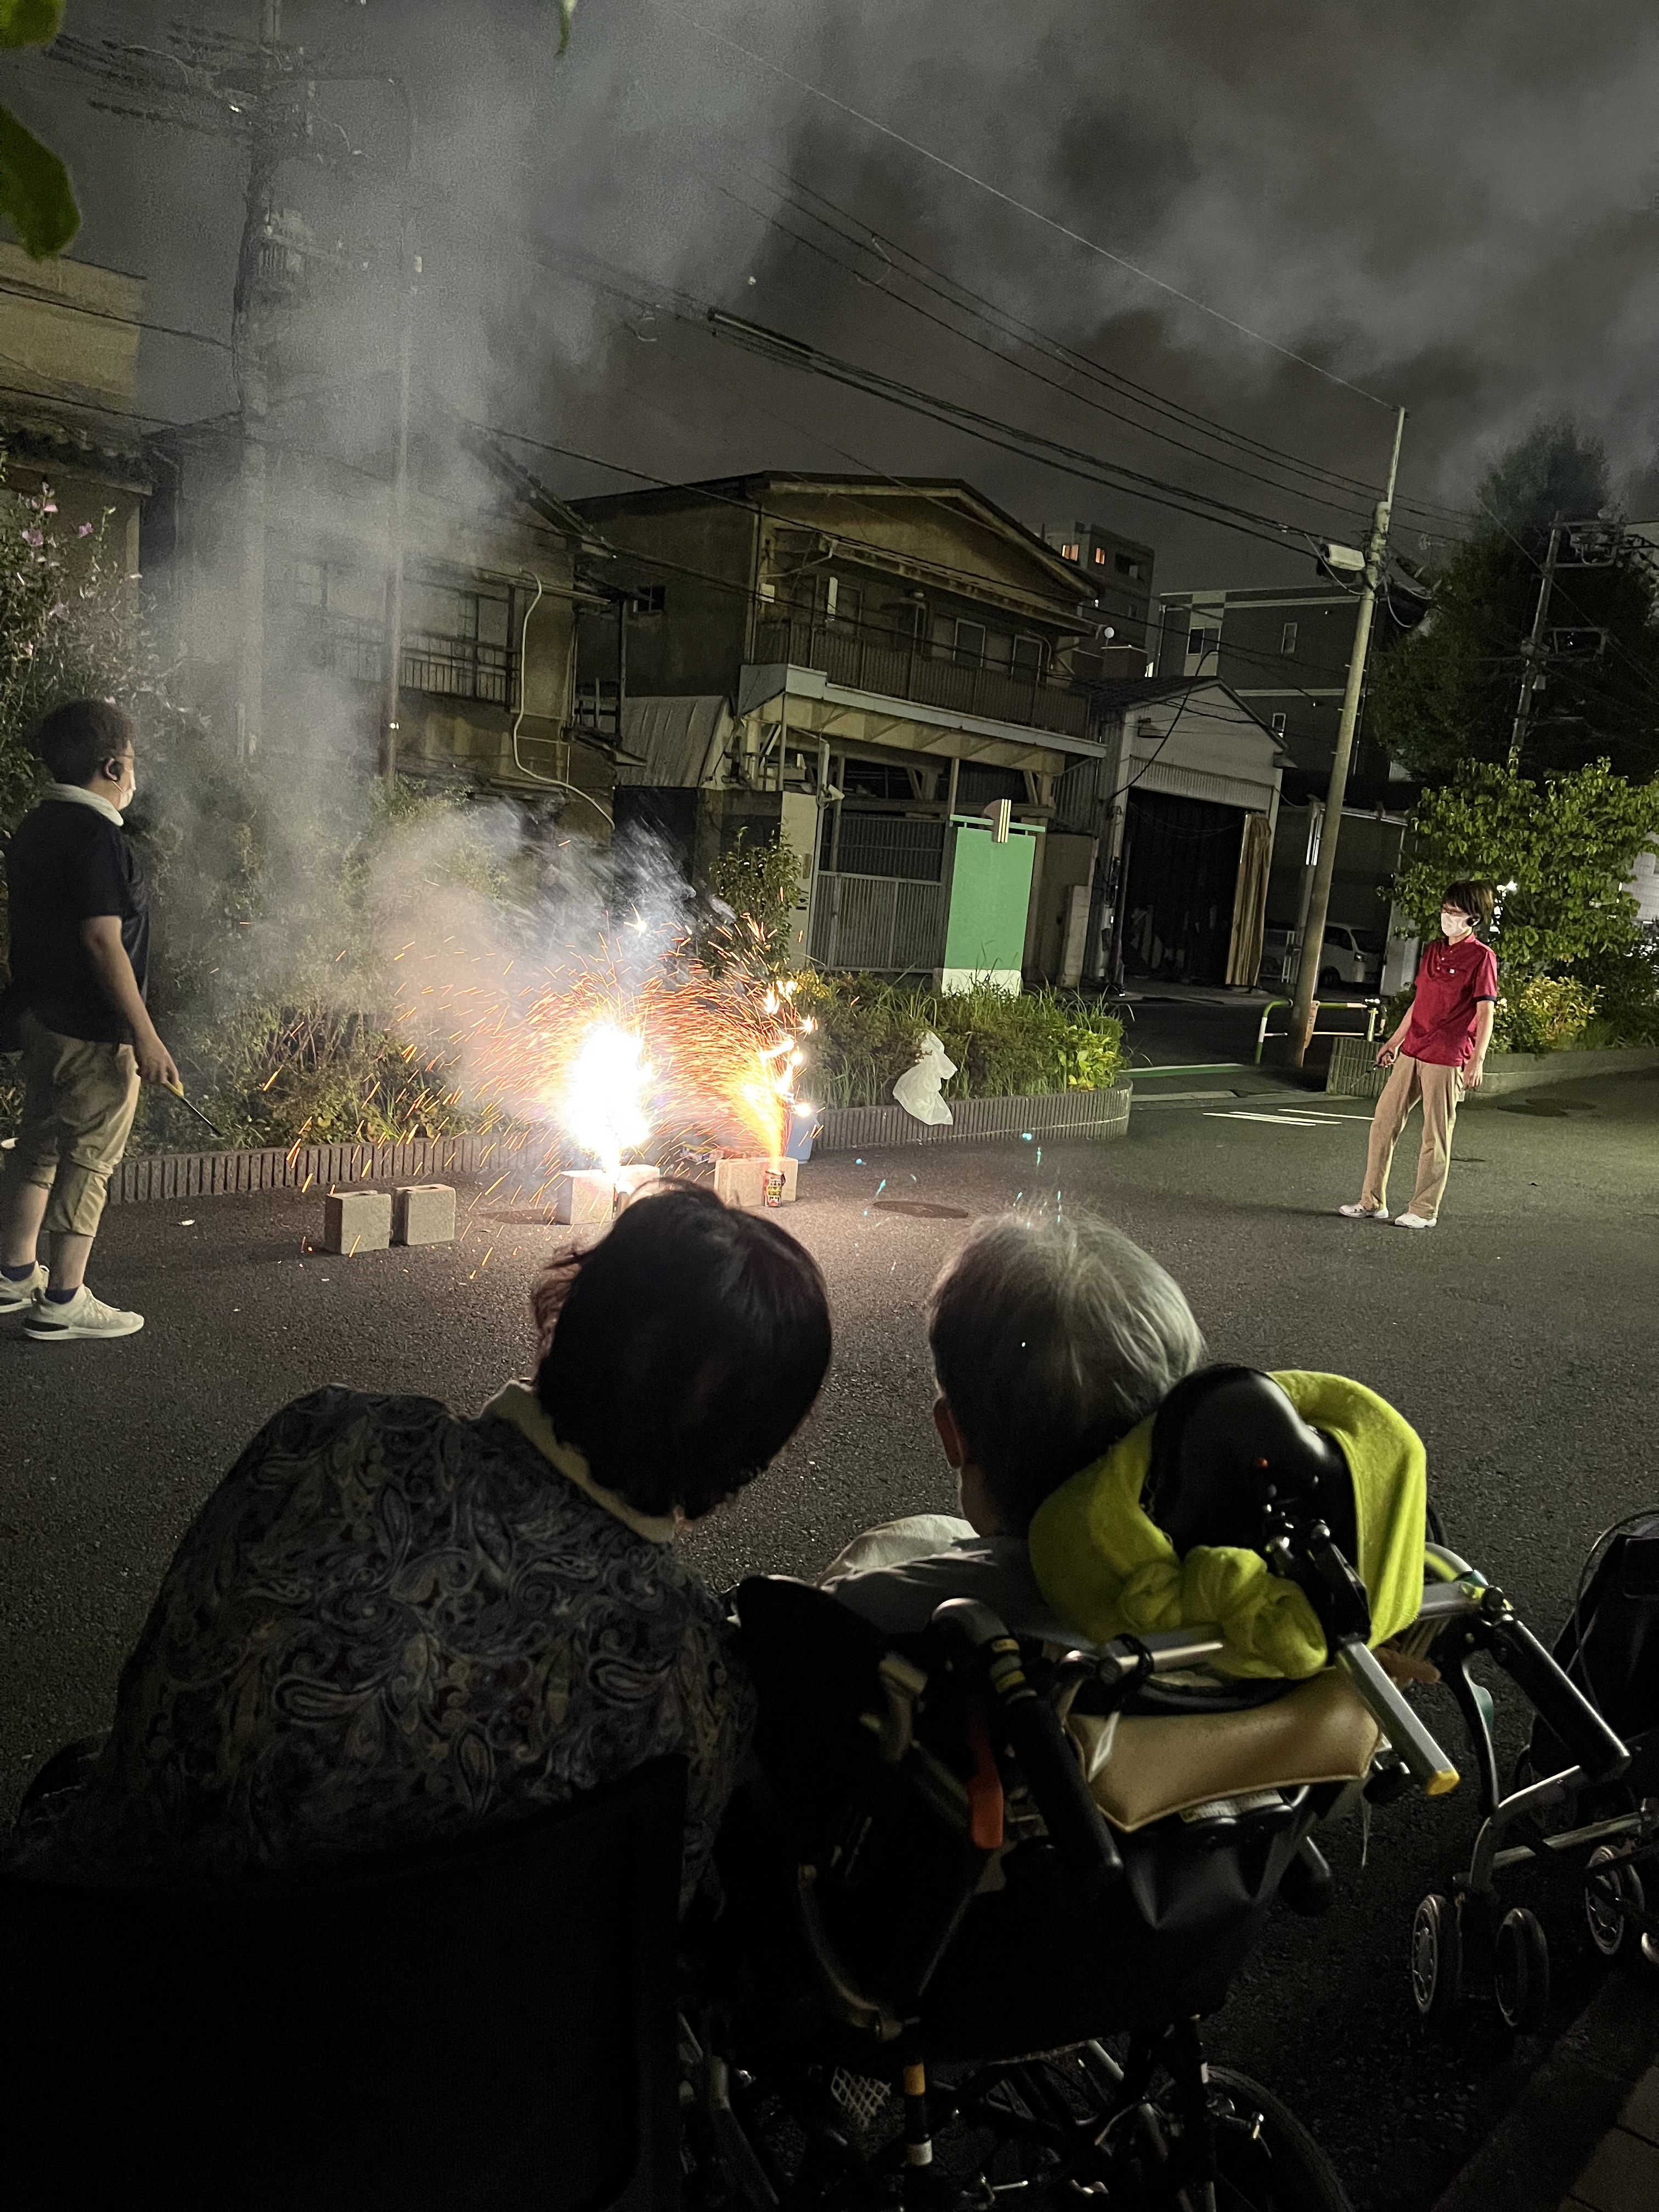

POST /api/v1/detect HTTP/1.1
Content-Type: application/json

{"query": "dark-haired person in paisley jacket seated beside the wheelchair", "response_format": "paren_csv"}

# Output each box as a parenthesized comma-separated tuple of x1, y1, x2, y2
(11, 1183, 830, 1898)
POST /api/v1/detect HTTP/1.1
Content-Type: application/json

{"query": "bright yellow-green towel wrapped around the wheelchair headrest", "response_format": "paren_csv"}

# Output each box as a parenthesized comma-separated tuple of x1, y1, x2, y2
(1029, 1369, 1427, 1677)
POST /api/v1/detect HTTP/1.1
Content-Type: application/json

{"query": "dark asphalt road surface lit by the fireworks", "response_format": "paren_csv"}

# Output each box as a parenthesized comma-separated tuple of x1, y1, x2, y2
(0, 1075, 1659, 2212)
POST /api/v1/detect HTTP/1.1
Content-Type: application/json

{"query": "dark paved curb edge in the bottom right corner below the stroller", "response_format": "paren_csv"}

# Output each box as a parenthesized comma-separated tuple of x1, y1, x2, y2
(1434, 1964, 1659, 2212)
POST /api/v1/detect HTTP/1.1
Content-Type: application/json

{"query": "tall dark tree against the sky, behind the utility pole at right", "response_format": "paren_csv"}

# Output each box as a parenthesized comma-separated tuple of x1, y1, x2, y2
(1367, 420, 1659, 783)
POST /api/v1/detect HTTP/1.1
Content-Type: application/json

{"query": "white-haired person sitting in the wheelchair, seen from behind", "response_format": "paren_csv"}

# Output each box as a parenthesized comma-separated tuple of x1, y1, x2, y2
(823, 1215, 1207, 1641)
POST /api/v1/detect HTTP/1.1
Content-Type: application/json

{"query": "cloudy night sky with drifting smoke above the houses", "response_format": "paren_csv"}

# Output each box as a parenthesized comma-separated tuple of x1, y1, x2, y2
(7, 0, 1659, 589)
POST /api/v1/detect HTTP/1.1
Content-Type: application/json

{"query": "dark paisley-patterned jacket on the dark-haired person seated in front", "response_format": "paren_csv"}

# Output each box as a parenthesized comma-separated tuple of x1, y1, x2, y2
(11, 1385, 752, 1898)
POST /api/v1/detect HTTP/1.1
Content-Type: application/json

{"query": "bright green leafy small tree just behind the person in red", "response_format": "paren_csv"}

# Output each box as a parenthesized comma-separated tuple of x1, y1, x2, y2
(1393, 761, 1659, 997)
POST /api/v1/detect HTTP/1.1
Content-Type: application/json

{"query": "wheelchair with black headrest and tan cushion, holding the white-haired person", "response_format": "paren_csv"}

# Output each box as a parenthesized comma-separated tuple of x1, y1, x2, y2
(681, 1369, 1628, 2212)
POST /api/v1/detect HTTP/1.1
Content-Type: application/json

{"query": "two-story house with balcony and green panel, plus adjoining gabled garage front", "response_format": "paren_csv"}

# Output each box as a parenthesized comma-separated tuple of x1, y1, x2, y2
(575, 473, 1278, 989)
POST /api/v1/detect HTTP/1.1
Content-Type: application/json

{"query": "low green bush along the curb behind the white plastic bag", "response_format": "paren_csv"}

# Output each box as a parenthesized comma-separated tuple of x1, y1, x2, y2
(794, 973, 1124, 1106)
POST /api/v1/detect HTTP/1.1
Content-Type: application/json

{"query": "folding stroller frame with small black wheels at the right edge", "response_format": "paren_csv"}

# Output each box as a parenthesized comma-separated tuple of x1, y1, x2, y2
(1411, 1544, 1659, 2035)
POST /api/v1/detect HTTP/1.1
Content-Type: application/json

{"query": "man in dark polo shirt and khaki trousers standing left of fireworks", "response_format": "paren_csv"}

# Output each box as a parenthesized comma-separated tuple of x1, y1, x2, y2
(0, 699, 179, 1345)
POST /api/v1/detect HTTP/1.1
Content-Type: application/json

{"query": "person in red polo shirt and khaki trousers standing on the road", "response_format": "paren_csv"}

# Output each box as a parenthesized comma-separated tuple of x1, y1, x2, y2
(1338, 883, 1498, 1230)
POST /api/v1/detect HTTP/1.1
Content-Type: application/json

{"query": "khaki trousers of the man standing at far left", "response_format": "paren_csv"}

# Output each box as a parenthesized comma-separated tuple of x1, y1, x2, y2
(7, 1013, 139, 1237)
